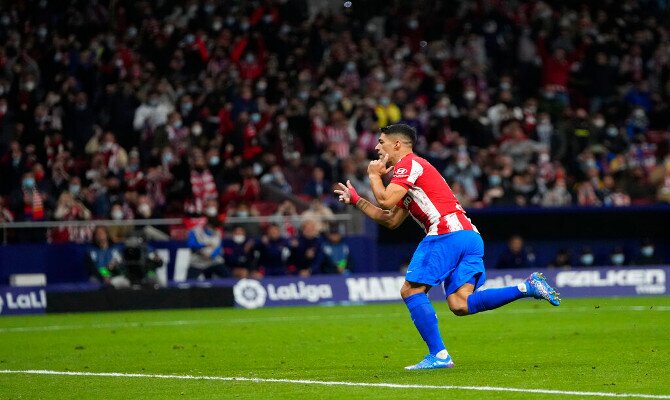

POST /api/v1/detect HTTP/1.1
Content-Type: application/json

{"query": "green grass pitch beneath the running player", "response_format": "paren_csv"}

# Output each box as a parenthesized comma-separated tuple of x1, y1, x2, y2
(0, 297, 670, 400)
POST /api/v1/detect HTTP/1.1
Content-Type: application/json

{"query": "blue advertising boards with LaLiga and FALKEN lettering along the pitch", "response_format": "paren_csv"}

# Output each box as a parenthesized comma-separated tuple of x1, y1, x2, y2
(0, 265, 670, 315)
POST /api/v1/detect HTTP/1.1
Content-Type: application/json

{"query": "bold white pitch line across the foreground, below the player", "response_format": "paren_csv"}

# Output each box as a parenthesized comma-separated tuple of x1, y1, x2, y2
(0, 369, 670, 399)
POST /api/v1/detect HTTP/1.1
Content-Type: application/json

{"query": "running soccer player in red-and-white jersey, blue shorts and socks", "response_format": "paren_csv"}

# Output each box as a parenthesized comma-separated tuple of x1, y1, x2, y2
(335, 124, 561, 370)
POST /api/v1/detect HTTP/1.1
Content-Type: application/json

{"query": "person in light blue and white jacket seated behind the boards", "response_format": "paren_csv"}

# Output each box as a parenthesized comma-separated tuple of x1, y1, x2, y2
(187, 217, 230, 279)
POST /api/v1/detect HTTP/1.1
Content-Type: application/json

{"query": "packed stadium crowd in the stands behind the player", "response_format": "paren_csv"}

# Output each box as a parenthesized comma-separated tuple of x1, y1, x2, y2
(0, 0, 670, 255)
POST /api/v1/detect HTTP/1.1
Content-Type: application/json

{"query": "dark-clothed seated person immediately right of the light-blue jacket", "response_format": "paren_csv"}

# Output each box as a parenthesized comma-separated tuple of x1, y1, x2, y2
(223, 225, 258, 278)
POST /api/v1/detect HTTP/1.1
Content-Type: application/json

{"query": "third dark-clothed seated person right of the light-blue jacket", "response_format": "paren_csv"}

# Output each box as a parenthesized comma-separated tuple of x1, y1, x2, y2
(291, 219, 324, 277)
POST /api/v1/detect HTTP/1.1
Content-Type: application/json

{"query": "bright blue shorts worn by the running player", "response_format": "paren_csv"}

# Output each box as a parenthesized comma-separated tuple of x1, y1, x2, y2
(405, 230, 486, 296)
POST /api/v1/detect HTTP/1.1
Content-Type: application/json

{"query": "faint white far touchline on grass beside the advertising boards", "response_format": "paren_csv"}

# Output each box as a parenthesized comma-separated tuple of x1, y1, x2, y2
(0, 306, 670, 334)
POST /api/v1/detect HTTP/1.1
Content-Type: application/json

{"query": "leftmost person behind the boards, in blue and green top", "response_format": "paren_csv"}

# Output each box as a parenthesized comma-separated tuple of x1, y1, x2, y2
(85, 226, 130, 289)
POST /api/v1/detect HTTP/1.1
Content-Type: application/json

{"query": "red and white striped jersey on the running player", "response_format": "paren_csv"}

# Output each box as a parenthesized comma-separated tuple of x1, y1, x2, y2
(391, 153, 479, 235)
